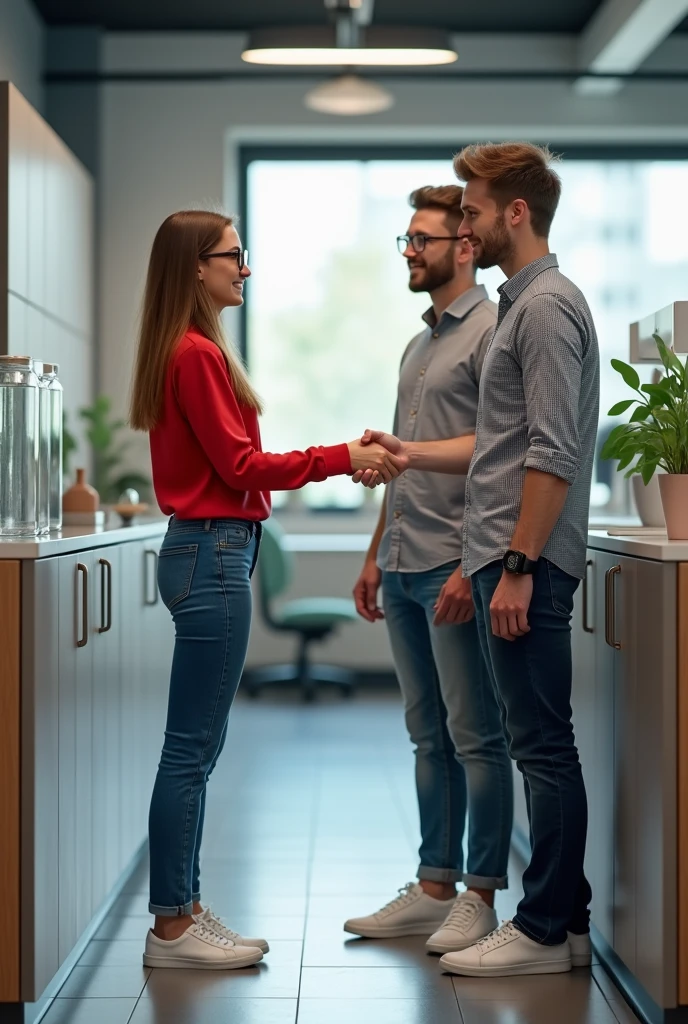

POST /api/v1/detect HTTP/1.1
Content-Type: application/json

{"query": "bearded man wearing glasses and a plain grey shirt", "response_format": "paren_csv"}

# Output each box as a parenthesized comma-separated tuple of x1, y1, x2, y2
(344, 185, 513, 953)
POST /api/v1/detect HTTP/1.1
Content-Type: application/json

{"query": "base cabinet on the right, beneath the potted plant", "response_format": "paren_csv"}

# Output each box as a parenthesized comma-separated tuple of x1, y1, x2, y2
(572, 549, 678, 1007)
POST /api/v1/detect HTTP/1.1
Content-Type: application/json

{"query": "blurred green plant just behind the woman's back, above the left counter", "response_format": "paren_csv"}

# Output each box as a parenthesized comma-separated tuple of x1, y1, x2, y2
(79, 394, 151, 505)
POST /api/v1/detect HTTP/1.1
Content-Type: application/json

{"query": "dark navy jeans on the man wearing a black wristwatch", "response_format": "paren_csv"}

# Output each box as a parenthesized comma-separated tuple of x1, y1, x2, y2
(472, 558, 592, 945)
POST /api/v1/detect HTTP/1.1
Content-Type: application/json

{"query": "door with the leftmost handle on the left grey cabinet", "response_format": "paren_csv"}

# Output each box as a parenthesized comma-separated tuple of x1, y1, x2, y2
(58, 552, 94, 962)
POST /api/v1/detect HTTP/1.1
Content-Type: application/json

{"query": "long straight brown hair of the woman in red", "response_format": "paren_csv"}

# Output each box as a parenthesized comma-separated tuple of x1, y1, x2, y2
(129, 210, 261, 430)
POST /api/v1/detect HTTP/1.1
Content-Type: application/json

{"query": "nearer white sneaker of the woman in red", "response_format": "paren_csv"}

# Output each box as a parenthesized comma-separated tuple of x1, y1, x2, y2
(143, 916, 263, 971)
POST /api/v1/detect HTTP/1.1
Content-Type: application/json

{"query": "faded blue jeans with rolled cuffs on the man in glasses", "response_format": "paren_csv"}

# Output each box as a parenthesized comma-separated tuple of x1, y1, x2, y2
(382, 562, 513, 889)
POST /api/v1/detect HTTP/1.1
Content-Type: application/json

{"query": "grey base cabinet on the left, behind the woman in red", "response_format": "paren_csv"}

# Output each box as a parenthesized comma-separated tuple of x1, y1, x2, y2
(7, 528, 174, 1001)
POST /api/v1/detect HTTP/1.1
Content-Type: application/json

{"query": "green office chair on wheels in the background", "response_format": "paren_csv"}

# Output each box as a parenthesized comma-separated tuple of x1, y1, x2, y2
(243, 519, 357, 700)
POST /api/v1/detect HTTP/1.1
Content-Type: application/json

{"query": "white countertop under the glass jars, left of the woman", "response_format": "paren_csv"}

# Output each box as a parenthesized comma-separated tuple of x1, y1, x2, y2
(0, 515, 168, 559)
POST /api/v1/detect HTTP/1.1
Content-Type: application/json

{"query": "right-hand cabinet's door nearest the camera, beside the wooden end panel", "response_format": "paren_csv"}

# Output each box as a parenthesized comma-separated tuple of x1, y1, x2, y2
(614, 557, 677, 1006)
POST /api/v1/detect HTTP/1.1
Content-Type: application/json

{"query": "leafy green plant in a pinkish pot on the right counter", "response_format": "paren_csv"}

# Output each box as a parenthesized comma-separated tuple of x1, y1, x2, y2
(601, 334, 688, 541)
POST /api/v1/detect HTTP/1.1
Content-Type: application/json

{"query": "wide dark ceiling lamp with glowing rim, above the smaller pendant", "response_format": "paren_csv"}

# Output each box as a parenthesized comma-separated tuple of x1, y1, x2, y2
(242, 26, 457, 68)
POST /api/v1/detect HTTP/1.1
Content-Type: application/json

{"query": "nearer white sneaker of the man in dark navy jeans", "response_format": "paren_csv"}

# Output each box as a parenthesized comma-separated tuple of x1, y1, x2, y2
(439, 921, 571, 978)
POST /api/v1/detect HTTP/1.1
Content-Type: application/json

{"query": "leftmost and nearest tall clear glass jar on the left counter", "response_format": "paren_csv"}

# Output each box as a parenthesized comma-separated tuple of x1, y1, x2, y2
(0, 355, 40, 537)
